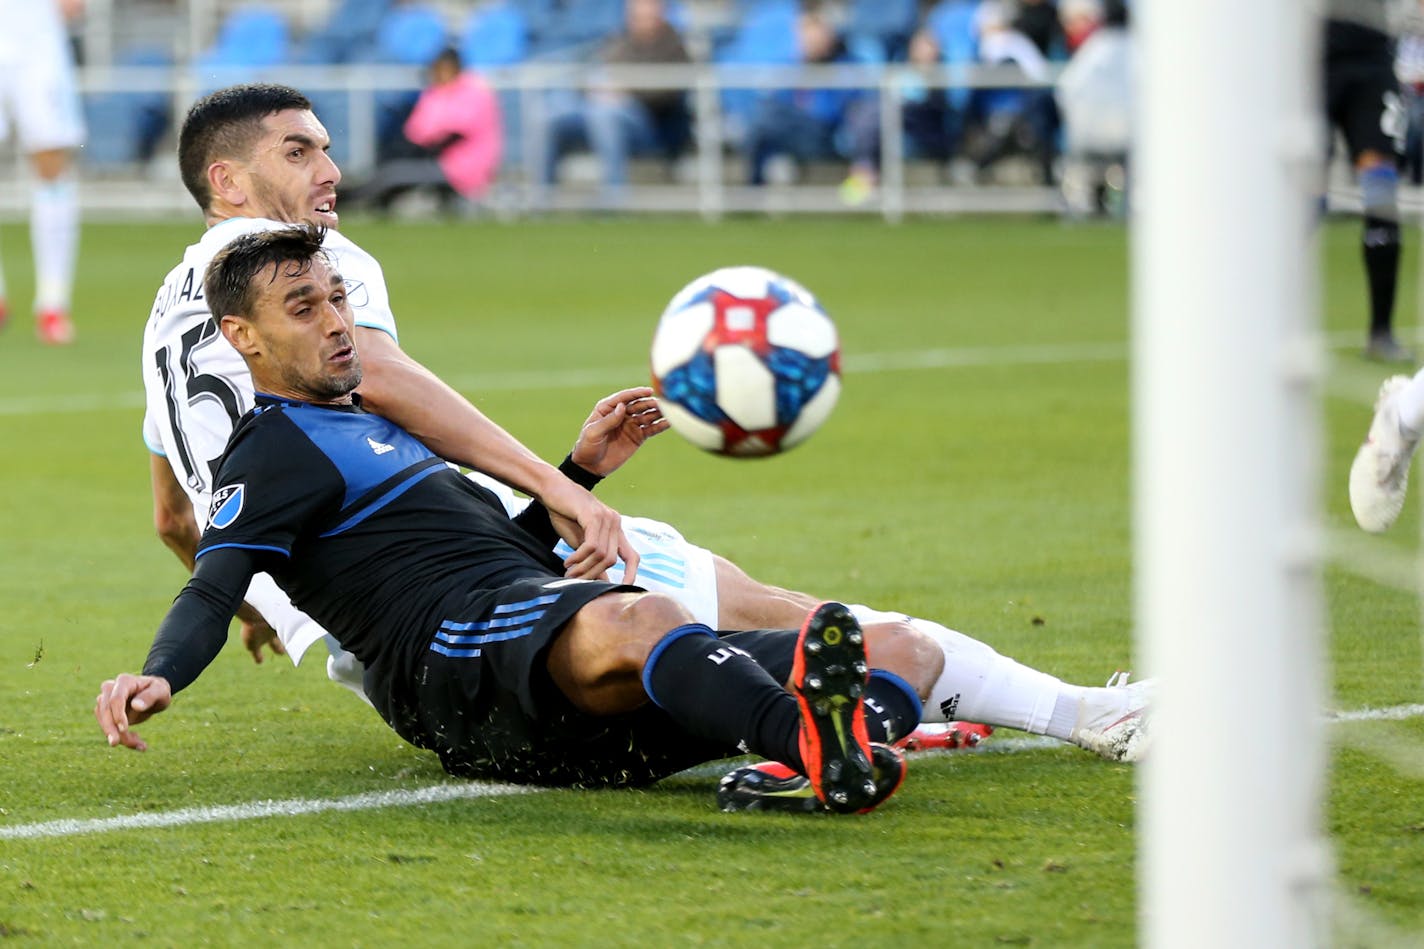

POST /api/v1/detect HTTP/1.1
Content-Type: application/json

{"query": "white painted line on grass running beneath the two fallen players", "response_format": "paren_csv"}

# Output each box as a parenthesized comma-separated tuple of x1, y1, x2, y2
(0, 705, 1424, 841)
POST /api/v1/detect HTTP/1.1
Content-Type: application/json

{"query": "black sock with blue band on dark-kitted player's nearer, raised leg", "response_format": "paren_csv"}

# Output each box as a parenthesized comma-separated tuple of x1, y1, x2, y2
(642, 623, 802, 769)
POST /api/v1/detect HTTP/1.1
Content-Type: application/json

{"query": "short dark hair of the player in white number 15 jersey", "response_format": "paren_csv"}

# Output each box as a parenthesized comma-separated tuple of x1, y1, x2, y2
(178, 83, 312, 211)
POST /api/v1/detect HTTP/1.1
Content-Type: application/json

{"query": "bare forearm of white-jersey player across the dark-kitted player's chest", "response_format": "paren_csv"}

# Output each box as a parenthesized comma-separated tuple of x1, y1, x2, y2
(357, 331, 562, 497)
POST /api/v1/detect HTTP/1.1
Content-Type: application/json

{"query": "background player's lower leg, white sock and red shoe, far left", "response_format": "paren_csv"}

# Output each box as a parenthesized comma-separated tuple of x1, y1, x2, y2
(30, 148, 80, 343)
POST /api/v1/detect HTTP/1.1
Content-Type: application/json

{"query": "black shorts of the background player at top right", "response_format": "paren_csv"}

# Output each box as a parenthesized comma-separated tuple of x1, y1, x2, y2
(1324, 20, 1407, 162)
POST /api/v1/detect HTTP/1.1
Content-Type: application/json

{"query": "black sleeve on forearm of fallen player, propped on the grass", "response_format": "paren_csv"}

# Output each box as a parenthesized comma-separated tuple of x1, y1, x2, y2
(144, 547, 267, 693)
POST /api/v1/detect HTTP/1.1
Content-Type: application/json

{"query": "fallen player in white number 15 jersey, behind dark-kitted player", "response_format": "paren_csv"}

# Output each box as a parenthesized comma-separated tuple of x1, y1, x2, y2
(144, 85, 1148, 758)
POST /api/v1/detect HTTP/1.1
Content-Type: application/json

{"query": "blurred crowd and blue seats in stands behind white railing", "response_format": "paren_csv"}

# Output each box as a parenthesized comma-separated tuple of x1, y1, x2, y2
(75, 0, 1128, 213)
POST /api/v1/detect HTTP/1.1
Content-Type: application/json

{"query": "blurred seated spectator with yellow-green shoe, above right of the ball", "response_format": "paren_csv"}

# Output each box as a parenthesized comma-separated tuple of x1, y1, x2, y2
(840, 28, 953, 205)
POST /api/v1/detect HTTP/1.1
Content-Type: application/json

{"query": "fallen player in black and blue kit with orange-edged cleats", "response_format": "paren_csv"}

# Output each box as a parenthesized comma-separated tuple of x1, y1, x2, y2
(95, 225, 920, 812)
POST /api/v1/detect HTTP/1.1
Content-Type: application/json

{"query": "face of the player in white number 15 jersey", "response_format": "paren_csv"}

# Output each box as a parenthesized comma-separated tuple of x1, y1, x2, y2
(239, 108, 342, 228)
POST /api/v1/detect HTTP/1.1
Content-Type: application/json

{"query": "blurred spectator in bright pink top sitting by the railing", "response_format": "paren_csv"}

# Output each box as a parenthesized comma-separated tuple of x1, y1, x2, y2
(346, 48, 504, 209)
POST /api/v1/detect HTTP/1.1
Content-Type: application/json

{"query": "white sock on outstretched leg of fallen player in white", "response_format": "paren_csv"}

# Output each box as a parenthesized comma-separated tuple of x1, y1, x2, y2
(850, 606, 1085, 738)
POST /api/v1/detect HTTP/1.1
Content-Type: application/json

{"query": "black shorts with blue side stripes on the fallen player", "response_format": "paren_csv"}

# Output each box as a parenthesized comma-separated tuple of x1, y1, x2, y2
(392, 580, 796, 788)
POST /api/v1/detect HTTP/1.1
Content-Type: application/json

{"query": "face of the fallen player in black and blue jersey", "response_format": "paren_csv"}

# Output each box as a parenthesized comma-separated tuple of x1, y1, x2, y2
(244, 258, 360, 402)
